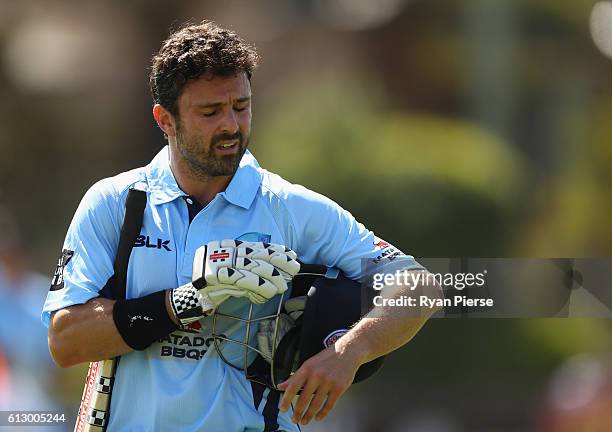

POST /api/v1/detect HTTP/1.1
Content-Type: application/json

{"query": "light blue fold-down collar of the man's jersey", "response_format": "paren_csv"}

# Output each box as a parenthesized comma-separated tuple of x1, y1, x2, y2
(146, 145, 262, 209)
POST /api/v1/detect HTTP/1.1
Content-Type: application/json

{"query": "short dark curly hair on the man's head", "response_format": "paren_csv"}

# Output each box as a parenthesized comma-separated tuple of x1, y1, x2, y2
(149, 21, 259, 116)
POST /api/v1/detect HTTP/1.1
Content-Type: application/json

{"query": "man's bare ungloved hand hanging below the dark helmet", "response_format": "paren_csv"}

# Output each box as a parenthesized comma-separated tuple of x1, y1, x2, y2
(278, 338, 361, 425)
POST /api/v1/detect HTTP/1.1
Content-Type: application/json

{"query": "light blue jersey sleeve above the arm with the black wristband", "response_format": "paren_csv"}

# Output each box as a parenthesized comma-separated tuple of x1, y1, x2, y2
(42, 179, 121, 327)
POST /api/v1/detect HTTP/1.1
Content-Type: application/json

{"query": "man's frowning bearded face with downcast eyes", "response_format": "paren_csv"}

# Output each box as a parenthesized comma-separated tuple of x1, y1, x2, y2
(176, 73, 251, 178)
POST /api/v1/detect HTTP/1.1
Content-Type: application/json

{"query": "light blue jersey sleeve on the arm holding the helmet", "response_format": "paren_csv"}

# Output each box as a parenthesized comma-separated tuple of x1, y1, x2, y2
(287, 186, 422, 280)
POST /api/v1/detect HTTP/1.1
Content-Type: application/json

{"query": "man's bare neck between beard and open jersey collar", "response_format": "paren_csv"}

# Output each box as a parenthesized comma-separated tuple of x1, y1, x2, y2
(170, 145, 232, 206)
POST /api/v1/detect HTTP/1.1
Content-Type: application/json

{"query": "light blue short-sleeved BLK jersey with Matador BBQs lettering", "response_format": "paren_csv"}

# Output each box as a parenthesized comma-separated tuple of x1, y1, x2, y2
(42, 147, 418, 432)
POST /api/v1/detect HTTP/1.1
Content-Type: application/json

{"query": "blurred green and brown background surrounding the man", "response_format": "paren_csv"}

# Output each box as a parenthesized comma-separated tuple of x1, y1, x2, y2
(0, 0, 612, 432)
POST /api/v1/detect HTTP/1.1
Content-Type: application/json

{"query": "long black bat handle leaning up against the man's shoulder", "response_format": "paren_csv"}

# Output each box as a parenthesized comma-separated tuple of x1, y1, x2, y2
(100, 189, 147, 300)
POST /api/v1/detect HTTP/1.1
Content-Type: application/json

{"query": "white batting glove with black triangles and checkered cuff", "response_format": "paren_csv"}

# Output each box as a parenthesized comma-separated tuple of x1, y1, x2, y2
(171, 240, 300, 326)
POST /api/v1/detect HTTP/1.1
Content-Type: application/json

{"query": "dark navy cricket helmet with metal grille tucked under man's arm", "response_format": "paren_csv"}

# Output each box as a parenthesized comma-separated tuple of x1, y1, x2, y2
(212, 264, 384, 389)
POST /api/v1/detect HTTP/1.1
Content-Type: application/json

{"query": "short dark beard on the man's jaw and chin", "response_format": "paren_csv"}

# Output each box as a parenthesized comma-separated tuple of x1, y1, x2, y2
(176, 127, 249, 179)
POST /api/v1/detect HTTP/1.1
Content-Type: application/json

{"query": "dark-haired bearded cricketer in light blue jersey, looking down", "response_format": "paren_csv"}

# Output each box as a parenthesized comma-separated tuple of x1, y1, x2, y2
(43, 22, 440, 431)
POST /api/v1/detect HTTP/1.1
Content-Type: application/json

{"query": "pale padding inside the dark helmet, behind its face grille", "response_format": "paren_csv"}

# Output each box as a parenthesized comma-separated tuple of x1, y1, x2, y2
(257, 296, 307, 363)
